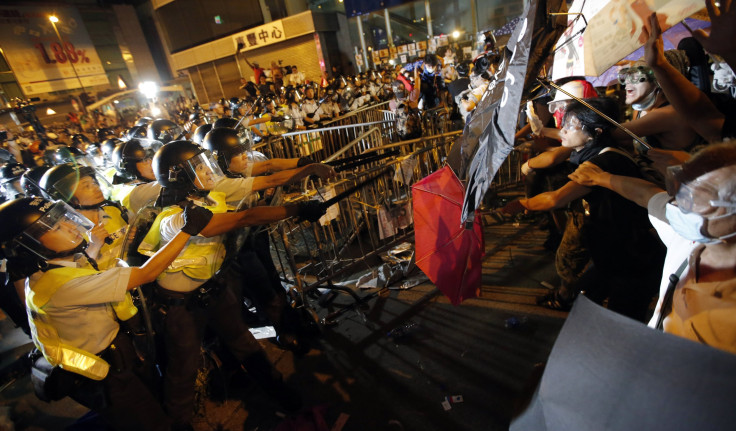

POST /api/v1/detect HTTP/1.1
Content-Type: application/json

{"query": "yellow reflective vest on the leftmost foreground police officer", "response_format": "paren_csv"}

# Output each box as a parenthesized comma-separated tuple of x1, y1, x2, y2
(26, 267, 138, 380)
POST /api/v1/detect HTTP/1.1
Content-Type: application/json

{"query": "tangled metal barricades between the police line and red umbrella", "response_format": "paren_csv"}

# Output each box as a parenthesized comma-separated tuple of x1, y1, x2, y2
(273, 131, 459, 292)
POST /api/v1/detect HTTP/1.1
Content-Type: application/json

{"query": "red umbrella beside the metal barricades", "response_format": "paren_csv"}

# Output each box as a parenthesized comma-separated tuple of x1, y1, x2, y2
(411, 166, 485, 305)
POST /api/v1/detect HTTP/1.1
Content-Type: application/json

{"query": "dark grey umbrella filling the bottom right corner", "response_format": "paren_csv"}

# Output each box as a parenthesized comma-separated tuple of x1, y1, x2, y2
(510, 296, 736, 431)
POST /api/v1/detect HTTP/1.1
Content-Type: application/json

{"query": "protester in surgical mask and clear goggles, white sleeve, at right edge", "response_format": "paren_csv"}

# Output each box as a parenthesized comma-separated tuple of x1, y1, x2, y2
(570, 142, 736, 353)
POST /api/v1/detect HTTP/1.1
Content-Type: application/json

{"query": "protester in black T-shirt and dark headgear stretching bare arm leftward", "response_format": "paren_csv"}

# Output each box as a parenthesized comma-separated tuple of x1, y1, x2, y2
(501, 98, 664, 321)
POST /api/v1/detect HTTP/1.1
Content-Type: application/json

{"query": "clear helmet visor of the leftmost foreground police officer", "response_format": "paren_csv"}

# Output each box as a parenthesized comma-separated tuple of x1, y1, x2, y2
(16, 201, 94, 259)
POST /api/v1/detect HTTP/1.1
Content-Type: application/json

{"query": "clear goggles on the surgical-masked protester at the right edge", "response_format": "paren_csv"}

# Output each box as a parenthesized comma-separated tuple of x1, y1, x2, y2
(665, 165, 736, 213)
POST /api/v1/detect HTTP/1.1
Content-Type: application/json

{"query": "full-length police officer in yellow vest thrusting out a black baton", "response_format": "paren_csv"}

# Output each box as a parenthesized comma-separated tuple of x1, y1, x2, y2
(138, 141, 324, 428)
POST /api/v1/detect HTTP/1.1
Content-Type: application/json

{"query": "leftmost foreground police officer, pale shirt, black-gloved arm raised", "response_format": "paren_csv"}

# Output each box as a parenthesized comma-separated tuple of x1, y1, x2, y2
(0, 197, 209, 430)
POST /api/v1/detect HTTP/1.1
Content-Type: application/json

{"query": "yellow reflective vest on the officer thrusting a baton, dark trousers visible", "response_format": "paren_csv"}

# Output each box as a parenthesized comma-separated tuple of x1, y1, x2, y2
(138, 192, 230, 280)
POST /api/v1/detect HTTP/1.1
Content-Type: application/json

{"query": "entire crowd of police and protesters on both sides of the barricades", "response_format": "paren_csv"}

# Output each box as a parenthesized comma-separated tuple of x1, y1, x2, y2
(0, 1, 736, 429)
